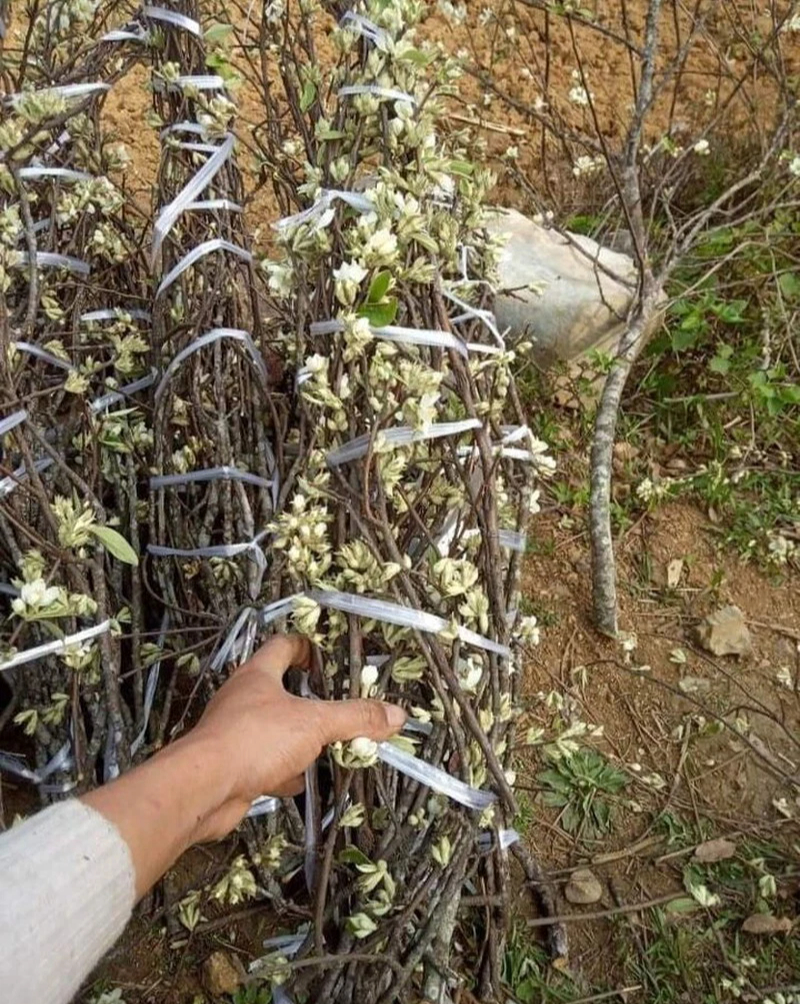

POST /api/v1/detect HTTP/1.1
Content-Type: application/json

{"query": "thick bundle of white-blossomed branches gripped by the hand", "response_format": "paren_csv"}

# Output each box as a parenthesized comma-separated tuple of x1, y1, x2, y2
(243, 2, 549, 1002)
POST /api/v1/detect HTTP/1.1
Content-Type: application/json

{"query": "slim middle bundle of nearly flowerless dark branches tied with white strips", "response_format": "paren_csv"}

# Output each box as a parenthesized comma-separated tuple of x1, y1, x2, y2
(149, 2, 287, 722)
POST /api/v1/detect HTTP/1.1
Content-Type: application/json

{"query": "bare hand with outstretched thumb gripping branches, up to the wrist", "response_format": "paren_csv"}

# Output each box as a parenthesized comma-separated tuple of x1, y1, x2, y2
(187, 635, 406, 840)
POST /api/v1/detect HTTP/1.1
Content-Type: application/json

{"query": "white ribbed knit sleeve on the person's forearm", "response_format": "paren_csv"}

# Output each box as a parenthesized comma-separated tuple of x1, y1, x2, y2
(0, 799, 135, 1004)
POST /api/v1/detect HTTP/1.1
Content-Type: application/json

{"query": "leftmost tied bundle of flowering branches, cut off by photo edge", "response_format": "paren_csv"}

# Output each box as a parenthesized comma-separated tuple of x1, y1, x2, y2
(0, 13, 152, 792)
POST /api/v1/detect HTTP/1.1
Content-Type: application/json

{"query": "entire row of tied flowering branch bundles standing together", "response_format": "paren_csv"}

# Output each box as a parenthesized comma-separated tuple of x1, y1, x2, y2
(0, 0, 552, 1004)
